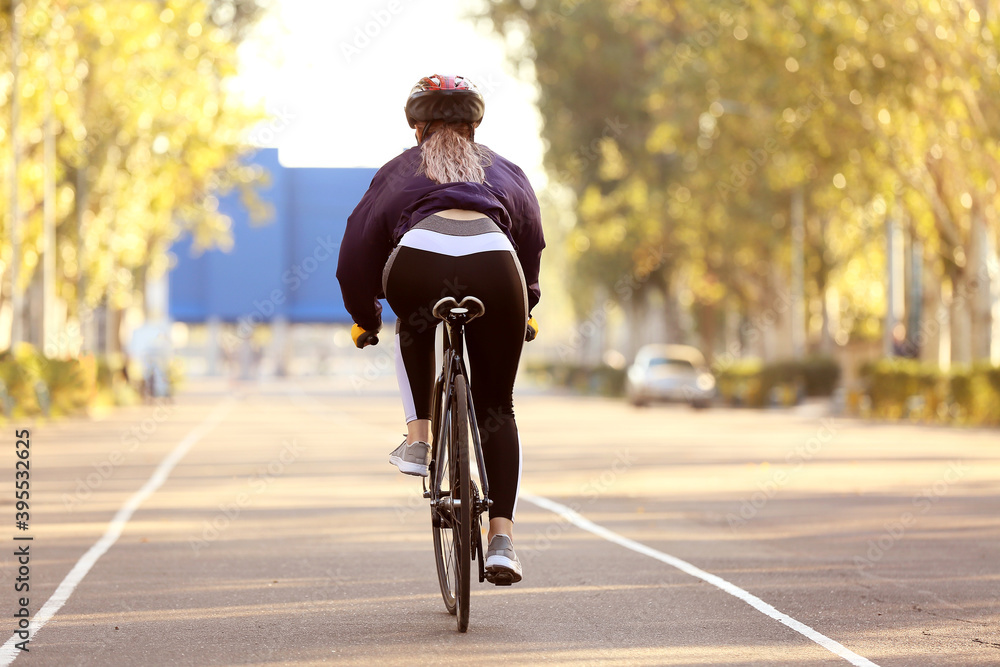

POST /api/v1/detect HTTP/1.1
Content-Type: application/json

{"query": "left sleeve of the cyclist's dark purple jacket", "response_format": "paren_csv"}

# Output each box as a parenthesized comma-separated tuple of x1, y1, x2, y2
(337, 163, 392, 331)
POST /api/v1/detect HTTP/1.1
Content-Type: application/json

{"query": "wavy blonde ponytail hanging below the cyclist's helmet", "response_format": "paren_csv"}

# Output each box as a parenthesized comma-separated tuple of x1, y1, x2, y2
(417, 122, 493, 183)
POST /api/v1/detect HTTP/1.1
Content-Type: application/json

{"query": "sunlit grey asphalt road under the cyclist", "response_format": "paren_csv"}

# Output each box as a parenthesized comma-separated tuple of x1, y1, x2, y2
(0, 380, 1000, 666)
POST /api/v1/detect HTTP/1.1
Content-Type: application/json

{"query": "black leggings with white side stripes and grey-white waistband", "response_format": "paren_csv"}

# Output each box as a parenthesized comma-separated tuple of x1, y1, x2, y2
(383, 215, 527, 520)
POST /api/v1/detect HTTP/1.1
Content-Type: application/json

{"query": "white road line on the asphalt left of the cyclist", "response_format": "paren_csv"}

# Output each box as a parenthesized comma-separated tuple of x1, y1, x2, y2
(0, 399, 235, 667)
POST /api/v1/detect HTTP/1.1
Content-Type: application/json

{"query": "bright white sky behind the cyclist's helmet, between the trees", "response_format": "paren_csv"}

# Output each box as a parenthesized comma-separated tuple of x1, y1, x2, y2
(235, 0, 545, 189)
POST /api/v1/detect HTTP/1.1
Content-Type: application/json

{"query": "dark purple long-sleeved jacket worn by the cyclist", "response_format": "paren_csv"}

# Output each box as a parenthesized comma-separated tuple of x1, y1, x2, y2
(337, 146, 545, 331)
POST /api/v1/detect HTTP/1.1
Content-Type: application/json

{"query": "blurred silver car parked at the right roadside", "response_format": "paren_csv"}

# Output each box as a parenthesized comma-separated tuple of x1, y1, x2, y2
(625, 345, 715, 409)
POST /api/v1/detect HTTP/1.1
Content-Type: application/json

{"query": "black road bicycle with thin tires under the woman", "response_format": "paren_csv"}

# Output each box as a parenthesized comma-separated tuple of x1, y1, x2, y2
(424, 296, 492, 632)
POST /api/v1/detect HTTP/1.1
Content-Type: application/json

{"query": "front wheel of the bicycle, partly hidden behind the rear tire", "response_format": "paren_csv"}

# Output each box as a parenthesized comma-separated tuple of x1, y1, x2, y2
(431, 392, 459, 616)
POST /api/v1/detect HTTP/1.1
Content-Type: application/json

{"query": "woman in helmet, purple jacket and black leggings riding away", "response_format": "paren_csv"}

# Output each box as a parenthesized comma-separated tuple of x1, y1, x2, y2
(337, 75, 545, 583)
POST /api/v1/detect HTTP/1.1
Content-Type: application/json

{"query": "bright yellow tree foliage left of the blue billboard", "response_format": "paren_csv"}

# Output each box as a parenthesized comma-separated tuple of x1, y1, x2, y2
(0, 0, 272, 353)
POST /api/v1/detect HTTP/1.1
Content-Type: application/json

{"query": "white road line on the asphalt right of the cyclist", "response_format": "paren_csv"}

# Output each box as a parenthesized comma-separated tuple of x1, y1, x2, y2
(521, 493, 878, 667)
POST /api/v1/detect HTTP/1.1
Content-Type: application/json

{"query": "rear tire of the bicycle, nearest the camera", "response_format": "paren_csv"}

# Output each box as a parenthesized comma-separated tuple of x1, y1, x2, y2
(451, 375, 473, 632)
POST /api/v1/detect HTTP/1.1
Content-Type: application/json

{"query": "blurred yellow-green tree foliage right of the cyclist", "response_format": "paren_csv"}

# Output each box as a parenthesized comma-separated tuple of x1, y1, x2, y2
(488, 0, 1000, 361)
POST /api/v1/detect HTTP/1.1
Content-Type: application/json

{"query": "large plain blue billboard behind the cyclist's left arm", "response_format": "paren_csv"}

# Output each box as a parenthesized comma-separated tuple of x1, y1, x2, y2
(169, 149, 380, 324)
